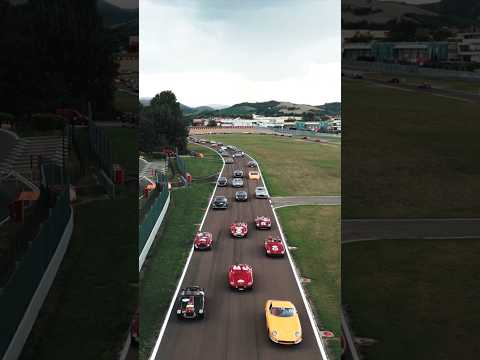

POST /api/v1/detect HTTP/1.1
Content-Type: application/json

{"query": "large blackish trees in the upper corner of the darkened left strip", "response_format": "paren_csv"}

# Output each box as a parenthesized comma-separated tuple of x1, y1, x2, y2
(0, 0, 117, 119)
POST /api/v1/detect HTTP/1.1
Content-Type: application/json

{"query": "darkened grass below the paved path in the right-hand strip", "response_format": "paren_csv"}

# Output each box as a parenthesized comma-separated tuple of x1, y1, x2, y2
(342, 240, 480, 360)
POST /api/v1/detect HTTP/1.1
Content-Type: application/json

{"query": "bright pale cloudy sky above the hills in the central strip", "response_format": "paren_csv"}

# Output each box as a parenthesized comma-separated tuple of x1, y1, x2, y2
(140, 0, 341, 106)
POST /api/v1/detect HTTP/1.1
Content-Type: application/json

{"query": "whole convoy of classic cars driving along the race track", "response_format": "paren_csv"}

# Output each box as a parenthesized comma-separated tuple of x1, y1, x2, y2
(180, 143, 302, 345)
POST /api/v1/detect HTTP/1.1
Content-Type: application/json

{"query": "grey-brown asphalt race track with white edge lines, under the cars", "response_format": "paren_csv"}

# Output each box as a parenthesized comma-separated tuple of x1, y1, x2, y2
(150, 142, 327, 360)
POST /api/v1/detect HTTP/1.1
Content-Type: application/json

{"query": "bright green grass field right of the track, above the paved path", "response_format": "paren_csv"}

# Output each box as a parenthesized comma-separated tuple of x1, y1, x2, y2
(204, 134, 340, 196)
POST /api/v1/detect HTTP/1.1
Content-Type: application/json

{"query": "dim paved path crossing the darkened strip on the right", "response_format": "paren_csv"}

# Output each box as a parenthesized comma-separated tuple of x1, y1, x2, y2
(342, 219, 480, 243)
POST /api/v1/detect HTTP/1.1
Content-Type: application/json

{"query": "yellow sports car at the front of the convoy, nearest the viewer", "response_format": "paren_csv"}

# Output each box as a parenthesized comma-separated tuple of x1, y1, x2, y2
(265, 300, 302, 345)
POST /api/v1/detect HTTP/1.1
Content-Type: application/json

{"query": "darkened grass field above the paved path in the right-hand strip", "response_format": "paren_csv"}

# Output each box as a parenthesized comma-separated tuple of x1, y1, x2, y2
(342, 81, 480, 218)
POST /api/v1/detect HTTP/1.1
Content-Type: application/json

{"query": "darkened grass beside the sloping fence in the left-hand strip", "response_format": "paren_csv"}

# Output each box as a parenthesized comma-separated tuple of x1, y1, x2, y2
(21, 197, 138, 360)
